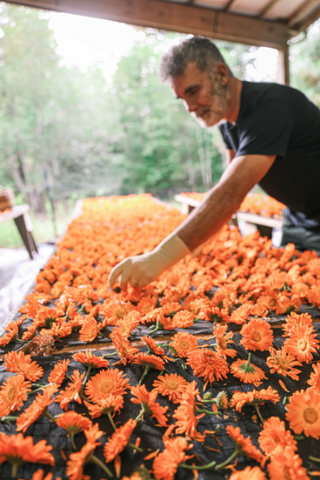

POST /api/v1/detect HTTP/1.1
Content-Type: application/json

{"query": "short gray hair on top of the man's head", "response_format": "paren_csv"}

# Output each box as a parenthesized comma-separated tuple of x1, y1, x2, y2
(159, 37, 233, 83)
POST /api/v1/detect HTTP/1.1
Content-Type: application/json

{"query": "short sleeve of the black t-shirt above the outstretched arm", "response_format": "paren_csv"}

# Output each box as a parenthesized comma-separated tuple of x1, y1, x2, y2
(236, 100, 292, 158)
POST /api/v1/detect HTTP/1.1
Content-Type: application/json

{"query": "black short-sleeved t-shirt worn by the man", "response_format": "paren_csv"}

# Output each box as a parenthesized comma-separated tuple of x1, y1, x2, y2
(219, 82, 320, 230)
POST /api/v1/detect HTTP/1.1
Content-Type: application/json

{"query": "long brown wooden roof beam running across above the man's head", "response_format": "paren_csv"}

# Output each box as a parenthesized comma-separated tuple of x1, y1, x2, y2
(6, 0, 288, 49)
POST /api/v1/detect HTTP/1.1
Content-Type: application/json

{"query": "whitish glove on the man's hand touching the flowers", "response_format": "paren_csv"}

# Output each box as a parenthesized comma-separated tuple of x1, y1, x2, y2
(109, 234, 190, 288)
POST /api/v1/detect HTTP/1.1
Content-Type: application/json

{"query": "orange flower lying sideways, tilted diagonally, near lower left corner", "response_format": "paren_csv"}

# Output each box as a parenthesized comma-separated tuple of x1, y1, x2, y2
(17, 385, 57, 432)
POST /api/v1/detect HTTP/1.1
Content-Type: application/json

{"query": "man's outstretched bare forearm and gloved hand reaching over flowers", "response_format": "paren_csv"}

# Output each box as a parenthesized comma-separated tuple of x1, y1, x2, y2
(109, 155, 275, 288)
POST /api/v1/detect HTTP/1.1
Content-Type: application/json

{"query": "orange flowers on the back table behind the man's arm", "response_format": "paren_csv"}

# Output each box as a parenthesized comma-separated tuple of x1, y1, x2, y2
(181, 192, 286, 218)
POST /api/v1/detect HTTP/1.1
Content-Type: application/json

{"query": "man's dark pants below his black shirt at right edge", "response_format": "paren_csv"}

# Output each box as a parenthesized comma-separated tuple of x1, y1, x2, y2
(281, 210, 320, 256)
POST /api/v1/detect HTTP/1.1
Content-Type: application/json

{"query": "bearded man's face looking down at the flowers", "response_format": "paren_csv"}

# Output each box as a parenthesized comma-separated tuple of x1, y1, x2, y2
(171, 63, 228, 128)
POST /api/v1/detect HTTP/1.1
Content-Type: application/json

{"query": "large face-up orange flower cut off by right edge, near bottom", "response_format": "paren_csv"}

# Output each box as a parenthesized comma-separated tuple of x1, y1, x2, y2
(286, 388, 320, 439)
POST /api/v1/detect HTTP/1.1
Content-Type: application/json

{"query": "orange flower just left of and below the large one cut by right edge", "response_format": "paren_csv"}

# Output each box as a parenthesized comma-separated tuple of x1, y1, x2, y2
(259, 417, 298, 455)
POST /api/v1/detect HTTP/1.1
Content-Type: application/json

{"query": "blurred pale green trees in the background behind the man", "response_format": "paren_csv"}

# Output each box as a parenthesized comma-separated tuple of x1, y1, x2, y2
(0, 3, 320, 247)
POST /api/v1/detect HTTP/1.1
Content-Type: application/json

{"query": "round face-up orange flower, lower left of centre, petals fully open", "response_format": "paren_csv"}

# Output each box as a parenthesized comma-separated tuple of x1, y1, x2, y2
(85, 368, 129, 404)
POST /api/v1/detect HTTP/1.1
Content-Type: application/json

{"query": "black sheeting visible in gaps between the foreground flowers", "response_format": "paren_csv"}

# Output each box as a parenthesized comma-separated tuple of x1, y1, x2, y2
(0, 322, 320, 480)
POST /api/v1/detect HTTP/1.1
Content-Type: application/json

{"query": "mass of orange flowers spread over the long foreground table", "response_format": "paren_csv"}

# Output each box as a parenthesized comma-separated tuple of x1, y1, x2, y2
(0, 195, 320, 480)
